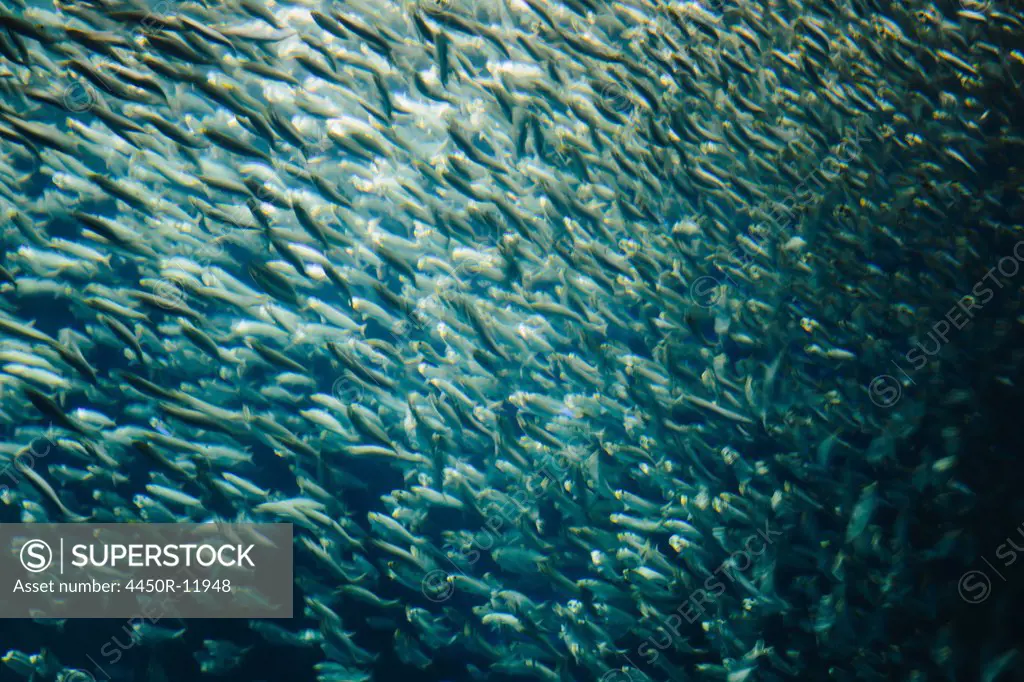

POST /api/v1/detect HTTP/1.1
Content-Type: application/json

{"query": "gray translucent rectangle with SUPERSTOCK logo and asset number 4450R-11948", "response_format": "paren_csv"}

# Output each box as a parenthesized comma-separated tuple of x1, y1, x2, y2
(0, 523, 293, 619)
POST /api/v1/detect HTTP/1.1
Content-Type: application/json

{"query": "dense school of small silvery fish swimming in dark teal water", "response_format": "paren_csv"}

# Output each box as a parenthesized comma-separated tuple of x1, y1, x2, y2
(0, 0, 1024, 682)
